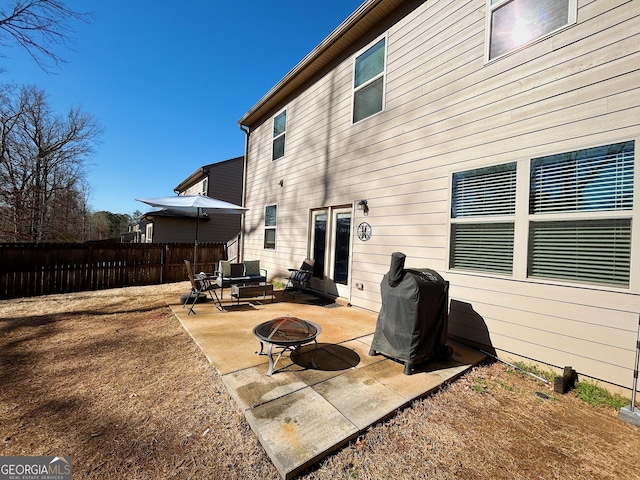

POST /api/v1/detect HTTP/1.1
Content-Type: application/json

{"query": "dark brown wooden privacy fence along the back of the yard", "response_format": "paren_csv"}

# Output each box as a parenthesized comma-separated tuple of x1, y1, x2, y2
(0, 243, 227, 298)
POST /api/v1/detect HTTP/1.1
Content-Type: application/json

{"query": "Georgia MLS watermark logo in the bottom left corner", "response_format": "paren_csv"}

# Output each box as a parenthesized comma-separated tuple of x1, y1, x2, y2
(0, 457, 71, 480)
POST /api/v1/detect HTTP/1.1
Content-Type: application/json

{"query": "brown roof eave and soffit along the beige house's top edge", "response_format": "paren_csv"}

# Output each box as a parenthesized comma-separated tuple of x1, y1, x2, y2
(238, 0, 406, 126)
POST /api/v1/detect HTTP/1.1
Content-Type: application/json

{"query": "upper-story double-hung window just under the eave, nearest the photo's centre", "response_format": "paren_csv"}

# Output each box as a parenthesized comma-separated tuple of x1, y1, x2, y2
(353, 38, 386, 123)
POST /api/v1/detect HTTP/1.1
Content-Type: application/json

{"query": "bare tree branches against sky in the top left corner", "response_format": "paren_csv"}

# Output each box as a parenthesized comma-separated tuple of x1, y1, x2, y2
(0, 0, 89, 71)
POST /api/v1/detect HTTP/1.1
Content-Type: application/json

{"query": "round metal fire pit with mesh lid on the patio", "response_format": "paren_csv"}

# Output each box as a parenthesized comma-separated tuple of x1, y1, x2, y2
(253, 315, 322, 377)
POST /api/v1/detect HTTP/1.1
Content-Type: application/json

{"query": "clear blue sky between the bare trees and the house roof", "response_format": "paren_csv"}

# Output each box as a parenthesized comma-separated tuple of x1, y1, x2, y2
(0, 0, 363, 214)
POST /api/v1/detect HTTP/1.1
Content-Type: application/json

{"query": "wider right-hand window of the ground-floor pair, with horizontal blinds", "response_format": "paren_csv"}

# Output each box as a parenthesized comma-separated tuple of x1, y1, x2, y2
(528, 141, 635, 286)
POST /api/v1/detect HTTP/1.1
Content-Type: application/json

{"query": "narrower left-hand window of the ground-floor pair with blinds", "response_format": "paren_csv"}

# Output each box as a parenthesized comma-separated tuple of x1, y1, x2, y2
(449, 163, 516, 274)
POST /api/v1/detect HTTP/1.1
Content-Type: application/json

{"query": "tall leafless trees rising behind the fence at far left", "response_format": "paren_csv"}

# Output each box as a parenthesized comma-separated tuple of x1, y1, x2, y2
(0, 86, 101, 243)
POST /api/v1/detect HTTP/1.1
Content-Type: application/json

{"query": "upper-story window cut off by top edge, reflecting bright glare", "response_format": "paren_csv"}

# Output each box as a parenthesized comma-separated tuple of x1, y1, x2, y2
(486, 0, 577, 60)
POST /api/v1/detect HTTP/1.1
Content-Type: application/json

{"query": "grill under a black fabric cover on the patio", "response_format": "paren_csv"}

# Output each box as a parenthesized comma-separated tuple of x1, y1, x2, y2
(369, 252, 451, 374)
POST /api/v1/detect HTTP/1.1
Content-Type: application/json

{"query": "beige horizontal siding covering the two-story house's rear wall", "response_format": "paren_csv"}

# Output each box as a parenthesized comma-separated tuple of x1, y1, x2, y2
(245, 0, 640, 386)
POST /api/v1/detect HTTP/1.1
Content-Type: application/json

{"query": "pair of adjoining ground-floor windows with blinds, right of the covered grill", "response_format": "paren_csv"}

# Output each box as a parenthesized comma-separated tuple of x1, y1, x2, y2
(449, 141, 635, 287)
